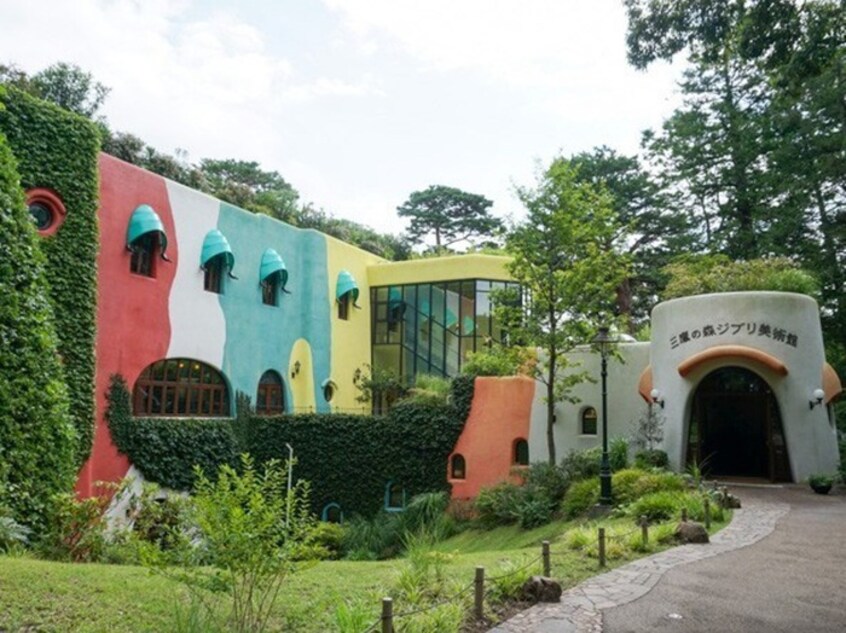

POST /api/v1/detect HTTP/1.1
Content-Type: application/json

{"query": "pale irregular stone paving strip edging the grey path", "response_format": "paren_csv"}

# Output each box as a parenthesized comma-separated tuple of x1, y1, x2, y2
(492, 500, 790, 633)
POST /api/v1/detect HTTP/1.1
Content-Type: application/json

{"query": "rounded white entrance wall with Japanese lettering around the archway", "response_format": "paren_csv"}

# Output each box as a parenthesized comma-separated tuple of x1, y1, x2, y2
(650, 292, 838, 481)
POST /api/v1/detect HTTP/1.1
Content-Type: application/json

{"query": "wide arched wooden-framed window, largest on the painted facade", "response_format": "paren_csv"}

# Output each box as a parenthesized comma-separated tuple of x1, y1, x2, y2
(133, 358, 230, 417)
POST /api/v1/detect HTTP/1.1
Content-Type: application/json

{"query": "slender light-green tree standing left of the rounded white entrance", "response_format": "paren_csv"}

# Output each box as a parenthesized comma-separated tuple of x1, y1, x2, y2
(504, 158, 628, 464)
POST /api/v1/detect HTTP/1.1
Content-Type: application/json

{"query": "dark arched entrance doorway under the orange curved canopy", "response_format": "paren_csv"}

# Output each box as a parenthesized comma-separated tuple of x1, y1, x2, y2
(687, 367, 791, 481)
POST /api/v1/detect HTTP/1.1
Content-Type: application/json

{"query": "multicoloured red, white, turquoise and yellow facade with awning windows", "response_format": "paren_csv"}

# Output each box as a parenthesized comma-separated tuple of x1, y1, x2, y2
(73, 154, 508, 495)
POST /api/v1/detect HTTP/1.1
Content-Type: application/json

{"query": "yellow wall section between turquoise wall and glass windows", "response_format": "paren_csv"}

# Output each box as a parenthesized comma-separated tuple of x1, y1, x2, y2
(324, 232, 385, 413)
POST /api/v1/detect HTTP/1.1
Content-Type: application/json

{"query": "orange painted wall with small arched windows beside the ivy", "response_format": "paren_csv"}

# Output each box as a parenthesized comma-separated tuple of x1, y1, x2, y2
(447, 377, 535, 499)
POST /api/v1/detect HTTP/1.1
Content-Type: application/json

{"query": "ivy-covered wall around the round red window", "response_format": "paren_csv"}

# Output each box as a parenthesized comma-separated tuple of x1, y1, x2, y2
(0, 88, 99, 466)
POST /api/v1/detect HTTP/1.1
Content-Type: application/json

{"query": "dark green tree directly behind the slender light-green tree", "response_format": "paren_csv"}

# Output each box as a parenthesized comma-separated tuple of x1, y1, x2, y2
(570, 147, 696, 334)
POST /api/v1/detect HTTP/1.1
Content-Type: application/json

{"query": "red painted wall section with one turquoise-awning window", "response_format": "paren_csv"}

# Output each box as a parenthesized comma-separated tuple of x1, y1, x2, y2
(77, 154, 179, 497)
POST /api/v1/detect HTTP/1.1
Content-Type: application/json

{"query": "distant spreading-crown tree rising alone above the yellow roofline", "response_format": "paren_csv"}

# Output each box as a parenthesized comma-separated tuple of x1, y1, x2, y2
(397, 185, 502, 251)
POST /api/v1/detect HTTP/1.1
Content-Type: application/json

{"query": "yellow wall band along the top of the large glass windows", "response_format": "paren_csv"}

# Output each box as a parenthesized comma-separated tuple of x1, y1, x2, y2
(366, 255, 511, 286)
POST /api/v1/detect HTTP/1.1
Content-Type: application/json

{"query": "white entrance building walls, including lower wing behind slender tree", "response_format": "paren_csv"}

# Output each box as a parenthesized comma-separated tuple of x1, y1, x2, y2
(529, 292, 839, 481)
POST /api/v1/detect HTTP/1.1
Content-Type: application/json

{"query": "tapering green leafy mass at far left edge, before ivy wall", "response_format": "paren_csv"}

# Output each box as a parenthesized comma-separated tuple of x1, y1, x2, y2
(0, 110, 77, 534)
